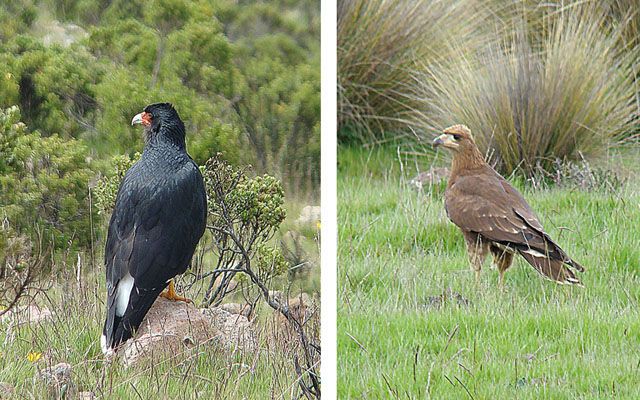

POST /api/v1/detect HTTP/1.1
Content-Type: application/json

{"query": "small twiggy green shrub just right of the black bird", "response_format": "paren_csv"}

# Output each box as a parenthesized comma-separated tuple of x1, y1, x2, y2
(203, 155, 288, 304)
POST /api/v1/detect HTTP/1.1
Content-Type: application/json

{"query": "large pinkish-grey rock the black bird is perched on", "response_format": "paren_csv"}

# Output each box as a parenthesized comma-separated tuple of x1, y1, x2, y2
(119, 297, 257, 366)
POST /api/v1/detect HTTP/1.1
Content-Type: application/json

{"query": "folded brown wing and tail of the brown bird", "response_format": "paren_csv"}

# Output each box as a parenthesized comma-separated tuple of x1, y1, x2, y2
(445, 168, 584, 284)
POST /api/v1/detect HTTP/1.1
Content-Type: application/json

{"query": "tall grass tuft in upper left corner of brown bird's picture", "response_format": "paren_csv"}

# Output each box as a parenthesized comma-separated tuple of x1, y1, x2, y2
(338, 0, 487, 142)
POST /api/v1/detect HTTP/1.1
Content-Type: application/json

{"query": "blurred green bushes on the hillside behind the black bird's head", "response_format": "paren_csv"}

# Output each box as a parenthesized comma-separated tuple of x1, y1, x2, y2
(0, 0, 320, 195)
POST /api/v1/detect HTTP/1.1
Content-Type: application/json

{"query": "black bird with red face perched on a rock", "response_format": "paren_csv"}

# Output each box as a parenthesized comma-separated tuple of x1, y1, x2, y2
(101, 103, 207, 354)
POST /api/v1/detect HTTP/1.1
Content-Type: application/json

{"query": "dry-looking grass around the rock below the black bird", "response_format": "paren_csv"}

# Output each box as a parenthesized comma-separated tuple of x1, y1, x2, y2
(0, 275, 308, 399)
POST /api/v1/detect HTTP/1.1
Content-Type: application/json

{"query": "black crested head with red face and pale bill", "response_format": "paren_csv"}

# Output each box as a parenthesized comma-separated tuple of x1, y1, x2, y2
(131, 103, 185, 149)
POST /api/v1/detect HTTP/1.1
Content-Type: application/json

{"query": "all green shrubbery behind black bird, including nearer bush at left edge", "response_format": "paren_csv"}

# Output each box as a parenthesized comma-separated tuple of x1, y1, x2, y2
(0, 0, 320, 266)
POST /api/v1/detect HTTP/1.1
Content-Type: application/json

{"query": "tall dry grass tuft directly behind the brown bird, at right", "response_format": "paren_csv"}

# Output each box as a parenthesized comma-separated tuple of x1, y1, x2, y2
(422, 8, 638, 175)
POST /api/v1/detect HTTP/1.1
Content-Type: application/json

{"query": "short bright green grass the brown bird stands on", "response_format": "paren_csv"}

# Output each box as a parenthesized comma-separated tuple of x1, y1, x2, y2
(338, 148, 640, 399)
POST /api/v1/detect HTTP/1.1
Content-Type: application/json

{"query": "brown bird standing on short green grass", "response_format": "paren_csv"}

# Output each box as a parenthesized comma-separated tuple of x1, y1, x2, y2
(433, 125, 584, 285)
